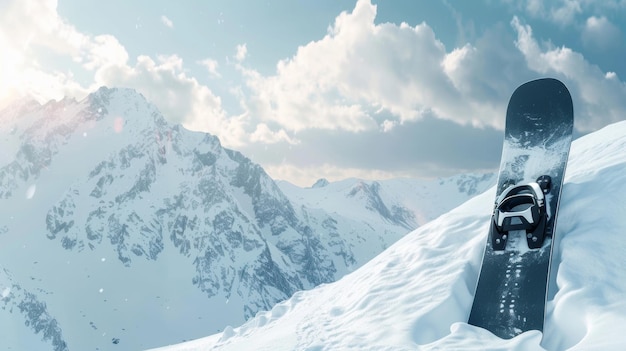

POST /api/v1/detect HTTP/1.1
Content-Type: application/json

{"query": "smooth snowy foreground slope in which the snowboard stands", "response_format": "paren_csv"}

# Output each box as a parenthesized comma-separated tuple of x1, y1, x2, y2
(149, 122, 626, 351)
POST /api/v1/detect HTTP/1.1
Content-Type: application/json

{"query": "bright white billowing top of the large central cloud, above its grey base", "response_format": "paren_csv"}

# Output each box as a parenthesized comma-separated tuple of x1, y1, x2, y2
(241, 0, 513, 132)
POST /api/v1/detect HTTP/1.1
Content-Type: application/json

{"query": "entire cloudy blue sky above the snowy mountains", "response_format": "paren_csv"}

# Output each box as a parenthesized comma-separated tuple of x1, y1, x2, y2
(0, 0, 626, 186)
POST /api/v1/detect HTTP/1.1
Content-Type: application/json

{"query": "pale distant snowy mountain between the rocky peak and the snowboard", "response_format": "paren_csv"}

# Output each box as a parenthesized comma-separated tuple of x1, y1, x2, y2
(277, 173, 496, 232)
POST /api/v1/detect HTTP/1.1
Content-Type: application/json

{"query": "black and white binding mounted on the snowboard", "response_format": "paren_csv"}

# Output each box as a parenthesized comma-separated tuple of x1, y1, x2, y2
(491, 175, 552, 251)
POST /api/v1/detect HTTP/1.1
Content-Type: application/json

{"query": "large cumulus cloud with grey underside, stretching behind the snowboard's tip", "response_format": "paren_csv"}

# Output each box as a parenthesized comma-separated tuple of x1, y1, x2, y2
(240, 1, 626, 185)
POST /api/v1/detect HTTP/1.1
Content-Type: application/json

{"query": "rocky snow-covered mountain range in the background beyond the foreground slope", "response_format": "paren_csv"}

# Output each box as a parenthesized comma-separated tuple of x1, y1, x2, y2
(0, 88, 495, 350)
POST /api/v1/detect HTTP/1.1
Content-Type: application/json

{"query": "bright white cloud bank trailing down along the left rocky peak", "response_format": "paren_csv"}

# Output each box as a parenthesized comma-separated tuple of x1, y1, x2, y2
(0, 0, 246, 146)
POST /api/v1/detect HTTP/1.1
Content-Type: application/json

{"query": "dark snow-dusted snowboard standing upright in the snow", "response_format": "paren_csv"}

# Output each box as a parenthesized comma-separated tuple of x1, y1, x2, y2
(468, 78, 574, 339)
